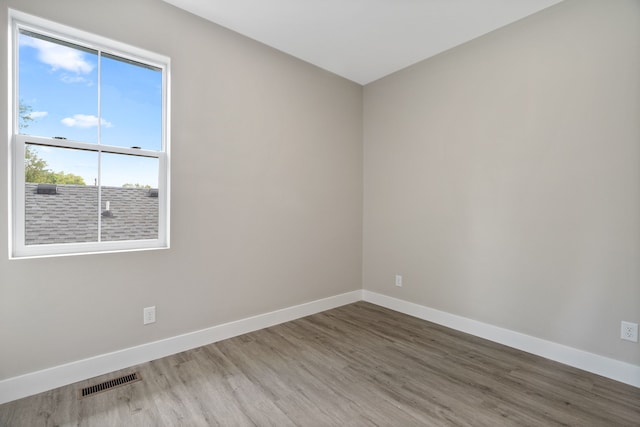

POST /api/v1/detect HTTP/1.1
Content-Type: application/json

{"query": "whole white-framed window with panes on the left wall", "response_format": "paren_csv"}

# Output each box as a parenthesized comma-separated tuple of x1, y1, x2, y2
(9, 10, 169, 258)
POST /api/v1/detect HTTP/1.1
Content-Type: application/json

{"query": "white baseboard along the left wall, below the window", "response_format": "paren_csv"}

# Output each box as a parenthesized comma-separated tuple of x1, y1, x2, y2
(0, 290, 362, 404)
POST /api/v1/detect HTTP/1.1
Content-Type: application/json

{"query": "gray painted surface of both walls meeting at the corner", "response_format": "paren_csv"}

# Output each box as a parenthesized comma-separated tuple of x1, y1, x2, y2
(0, 0, 640, 379)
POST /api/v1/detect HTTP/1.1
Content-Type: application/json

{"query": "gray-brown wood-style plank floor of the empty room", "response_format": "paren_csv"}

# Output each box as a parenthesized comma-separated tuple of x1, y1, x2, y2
(0, 302, 640, 427)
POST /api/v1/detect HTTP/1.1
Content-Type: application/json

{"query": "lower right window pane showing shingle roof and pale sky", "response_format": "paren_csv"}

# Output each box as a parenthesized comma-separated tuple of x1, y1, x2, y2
(101, 153, 159, 241)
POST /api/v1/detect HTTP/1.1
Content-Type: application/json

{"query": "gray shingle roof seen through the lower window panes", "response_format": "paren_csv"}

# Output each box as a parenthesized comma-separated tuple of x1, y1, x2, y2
(25, 183, 158, 245)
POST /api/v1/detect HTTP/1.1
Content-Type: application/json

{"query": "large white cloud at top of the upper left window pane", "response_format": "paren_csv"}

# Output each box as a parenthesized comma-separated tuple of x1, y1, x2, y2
(20, 37, 95, 74)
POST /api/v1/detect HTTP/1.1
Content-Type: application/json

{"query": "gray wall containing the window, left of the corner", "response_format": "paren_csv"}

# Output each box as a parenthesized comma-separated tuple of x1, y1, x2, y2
(0, 0, 362, 379)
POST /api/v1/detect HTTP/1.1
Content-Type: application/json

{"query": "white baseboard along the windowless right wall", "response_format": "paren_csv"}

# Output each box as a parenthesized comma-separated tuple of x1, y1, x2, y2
(362, 290, 640, 387)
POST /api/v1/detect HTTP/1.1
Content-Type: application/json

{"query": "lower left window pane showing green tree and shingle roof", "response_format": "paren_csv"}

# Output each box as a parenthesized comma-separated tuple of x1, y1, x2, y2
(25, 144, 98, 245)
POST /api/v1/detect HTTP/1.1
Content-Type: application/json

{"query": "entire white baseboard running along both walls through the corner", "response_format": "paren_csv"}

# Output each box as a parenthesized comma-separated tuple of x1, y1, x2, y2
(0, 290, 640, 404)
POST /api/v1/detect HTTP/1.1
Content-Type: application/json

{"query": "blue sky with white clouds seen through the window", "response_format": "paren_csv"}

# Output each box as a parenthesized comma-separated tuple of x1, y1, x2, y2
(18, 34, 162, 187)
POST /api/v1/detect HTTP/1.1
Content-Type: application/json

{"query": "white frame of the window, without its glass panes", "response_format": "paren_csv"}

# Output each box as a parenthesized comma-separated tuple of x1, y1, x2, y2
(8, 9, 170, 259)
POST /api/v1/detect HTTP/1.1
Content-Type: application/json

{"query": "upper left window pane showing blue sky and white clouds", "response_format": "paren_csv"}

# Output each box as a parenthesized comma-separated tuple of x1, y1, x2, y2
(18, 31, 99, 143)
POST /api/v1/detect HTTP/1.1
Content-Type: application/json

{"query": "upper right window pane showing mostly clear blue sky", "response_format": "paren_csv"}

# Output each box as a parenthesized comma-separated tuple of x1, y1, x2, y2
(100, 55, 162, 151)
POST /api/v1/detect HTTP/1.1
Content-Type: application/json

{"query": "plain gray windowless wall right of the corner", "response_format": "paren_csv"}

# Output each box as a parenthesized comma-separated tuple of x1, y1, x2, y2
(363, 0, 640, 365)
